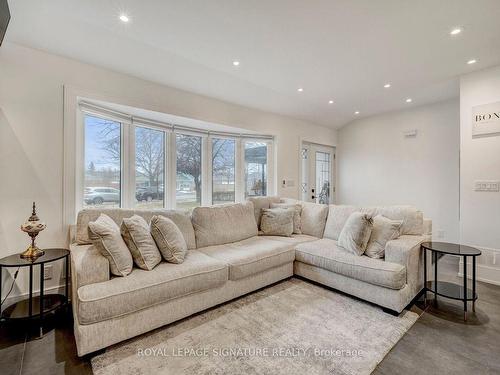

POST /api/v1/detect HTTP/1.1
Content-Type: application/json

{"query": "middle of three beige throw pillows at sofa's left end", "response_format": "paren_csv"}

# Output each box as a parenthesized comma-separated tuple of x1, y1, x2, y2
(120, 215, 161, 271)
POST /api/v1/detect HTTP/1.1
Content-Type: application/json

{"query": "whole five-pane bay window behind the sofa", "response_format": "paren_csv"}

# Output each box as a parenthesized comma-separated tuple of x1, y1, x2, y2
(74, 102, 275, 213)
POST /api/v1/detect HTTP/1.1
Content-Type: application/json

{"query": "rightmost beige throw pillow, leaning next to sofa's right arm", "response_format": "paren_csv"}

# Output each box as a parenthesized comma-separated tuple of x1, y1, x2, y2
(365, 215, 403, 258)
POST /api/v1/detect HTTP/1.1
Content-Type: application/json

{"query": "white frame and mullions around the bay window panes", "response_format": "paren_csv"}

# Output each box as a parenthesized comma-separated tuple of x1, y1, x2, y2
(63, 95, 276, 225)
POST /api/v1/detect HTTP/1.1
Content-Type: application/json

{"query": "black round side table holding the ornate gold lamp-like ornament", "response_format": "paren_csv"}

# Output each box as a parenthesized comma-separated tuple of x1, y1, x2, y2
(0, 249, 69, 336)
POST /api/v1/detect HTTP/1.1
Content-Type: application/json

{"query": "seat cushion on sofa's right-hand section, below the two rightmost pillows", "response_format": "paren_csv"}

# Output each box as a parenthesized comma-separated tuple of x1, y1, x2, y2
(295, 238, 406, 289)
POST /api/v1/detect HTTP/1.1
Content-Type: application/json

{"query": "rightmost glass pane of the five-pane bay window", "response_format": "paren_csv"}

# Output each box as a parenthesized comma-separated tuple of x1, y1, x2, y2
(245, 141, 267, 198)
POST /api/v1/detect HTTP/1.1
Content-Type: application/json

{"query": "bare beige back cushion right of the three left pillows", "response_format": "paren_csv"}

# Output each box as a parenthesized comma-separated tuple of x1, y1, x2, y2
(192, 202, 258, 248)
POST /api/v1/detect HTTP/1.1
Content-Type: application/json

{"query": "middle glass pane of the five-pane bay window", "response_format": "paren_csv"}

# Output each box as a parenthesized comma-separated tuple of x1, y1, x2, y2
(175, 134, 201, 209)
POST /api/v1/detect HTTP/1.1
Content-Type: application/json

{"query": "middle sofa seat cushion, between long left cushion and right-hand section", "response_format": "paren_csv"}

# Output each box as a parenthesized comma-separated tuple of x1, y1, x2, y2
(198, 237, 295, 280)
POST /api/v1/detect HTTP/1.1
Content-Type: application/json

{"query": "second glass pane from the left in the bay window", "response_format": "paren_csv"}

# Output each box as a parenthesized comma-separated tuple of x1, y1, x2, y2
(135, 126, 165, 209)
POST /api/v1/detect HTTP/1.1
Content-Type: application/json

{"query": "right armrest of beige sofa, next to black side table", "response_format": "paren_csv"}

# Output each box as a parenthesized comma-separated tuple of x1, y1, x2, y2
(385, 235, 430, 293)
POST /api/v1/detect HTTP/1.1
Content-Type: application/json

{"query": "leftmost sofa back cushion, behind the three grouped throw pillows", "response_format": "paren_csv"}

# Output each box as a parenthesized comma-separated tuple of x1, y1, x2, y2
(75, 208, 196, 249)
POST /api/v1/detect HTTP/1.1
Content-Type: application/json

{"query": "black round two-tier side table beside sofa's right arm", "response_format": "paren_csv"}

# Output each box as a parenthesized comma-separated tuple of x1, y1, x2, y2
(421, 241, 481, 321)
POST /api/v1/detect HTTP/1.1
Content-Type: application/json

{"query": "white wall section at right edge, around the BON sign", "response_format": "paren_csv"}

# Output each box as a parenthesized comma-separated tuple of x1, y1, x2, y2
(460, 67, 500, 284)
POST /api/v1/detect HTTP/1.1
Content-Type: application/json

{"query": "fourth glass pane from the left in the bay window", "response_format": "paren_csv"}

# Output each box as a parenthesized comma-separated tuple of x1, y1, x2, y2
(212, 138, 236, 204)
